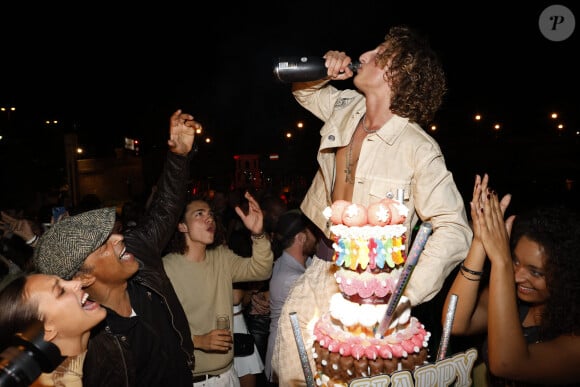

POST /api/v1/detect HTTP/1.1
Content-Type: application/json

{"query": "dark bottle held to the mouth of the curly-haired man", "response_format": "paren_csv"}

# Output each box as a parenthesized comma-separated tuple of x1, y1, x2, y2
(274, 56, 360, 83)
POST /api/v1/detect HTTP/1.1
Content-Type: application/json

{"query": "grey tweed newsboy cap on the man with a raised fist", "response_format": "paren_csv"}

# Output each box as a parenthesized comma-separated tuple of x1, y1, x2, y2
(33, 207, 115, 280)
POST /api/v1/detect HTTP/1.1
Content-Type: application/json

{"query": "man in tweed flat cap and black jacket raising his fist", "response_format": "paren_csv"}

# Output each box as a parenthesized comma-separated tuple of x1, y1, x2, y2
(33, 110, 200, 387)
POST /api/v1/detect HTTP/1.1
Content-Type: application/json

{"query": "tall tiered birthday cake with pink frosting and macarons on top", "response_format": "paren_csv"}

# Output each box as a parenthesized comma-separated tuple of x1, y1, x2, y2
(312, 199, 430, 386)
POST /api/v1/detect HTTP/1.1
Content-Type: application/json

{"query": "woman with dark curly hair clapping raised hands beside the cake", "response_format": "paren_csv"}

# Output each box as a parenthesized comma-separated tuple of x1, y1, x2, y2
(444, 175, 580, 386)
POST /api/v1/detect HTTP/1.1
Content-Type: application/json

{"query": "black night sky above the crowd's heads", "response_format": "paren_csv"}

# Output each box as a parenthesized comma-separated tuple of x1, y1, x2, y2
(0, 0, 580, 209)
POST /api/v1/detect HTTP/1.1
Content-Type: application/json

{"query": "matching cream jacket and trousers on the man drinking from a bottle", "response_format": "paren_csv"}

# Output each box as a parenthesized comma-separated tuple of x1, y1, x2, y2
(272, 82, 472, 387)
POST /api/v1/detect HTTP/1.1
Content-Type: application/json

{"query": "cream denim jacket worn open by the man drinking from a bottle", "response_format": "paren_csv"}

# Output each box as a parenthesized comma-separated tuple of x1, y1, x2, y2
(294, 82, 472, 305)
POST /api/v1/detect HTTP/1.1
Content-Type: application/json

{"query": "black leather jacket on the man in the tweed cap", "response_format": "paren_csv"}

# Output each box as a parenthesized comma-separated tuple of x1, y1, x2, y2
(83, 152, 195, 387)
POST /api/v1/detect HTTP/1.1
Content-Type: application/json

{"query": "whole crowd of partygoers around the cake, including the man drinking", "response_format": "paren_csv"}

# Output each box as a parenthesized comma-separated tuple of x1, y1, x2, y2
(0, 26, 580, 387)
